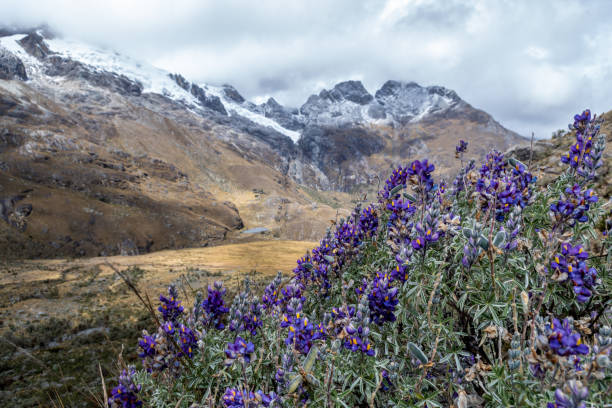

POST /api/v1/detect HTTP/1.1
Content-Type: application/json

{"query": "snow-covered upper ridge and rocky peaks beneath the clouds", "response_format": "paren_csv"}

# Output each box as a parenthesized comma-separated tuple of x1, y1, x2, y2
(0, 32, 498, 142)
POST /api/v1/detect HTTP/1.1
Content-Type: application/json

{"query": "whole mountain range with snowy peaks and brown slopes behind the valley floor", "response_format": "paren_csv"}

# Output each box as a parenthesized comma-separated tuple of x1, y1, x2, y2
(0, 30, 525, 257)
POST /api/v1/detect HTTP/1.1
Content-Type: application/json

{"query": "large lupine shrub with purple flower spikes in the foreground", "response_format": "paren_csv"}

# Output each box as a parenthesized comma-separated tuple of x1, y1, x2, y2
(111, 111, 612, 407)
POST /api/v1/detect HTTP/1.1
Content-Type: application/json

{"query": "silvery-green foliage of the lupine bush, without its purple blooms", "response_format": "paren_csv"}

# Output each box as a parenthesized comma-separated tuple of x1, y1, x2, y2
(107, 127, 612, 408)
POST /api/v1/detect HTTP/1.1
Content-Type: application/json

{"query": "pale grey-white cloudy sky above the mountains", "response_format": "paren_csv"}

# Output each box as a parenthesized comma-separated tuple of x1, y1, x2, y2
(0, 0, 612, 137)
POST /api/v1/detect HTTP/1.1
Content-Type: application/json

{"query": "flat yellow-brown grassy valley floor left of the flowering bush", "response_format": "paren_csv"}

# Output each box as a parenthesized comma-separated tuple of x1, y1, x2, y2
(0, 241, 315, 407)
